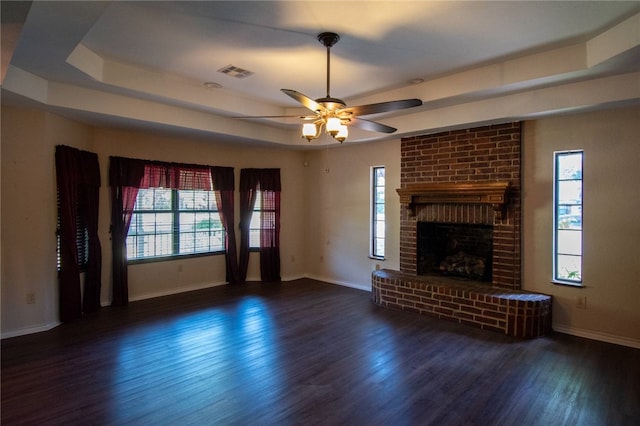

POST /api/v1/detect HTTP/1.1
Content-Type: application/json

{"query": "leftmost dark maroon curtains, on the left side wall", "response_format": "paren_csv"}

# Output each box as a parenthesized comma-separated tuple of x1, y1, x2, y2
(55, 145, 102, 322)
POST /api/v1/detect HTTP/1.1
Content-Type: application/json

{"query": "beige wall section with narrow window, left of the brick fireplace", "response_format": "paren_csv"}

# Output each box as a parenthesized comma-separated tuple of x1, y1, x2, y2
(305, 140, 400, 290)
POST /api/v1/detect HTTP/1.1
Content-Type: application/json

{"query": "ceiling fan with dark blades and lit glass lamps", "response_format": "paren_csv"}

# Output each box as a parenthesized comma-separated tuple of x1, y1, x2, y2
(238, 32, 422, 143)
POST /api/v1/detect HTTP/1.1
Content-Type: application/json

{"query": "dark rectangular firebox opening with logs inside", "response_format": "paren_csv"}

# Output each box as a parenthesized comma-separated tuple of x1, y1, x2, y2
(416, 222, 493, 283)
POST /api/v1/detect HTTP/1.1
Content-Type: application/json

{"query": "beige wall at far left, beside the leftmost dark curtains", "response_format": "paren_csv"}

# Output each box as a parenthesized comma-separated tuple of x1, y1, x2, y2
(0, 107, 91, 335)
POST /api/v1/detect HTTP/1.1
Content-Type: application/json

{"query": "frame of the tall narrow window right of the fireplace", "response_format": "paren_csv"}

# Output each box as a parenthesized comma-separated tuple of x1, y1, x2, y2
(551, 149, 584, 287)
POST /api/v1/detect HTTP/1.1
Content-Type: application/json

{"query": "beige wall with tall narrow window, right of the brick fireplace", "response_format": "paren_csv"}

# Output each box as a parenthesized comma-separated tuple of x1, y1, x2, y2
(523, 108, 640, 347)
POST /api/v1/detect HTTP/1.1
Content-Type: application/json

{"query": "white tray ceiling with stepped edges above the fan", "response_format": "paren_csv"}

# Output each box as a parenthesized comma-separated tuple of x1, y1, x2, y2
(2, 1, 640, 147)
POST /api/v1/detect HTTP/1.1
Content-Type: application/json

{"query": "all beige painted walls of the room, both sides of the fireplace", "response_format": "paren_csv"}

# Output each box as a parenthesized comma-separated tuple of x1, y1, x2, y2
(0, 106, 640, 347)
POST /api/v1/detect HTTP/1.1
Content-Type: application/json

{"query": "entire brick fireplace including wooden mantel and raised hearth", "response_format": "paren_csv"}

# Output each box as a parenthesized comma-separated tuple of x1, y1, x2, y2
(372, 123, 551, 338)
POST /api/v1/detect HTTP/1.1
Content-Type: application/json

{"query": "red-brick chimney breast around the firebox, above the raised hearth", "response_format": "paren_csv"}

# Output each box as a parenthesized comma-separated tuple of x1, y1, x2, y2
(400, 123, 521, 289)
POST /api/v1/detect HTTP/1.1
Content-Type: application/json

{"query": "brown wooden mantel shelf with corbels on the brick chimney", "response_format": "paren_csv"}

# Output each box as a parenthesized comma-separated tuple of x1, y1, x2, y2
(396, 182, 509, 219)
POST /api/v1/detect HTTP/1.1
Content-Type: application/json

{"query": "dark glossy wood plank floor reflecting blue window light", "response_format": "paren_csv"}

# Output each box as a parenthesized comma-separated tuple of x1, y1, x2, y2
(2, 280, 640, 426)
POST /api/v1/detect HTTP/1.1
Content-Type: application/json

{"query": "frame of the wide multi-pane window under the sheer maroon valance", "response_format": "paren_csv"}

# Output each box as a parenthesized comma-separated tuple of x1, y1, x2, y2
(126, 187, 226, 264)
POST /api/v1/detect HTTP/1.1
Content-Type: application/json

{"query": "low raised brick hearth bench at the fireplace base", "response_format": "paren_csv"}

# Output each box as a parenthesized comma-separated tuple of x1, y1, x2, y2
(371, 269, 551, 338)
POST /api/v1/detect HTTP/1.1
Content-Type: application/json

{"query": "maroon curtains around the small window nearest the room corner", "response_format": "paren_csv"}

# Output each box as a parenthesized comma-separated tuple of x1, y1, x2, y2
(239, 169, 281, 281)
